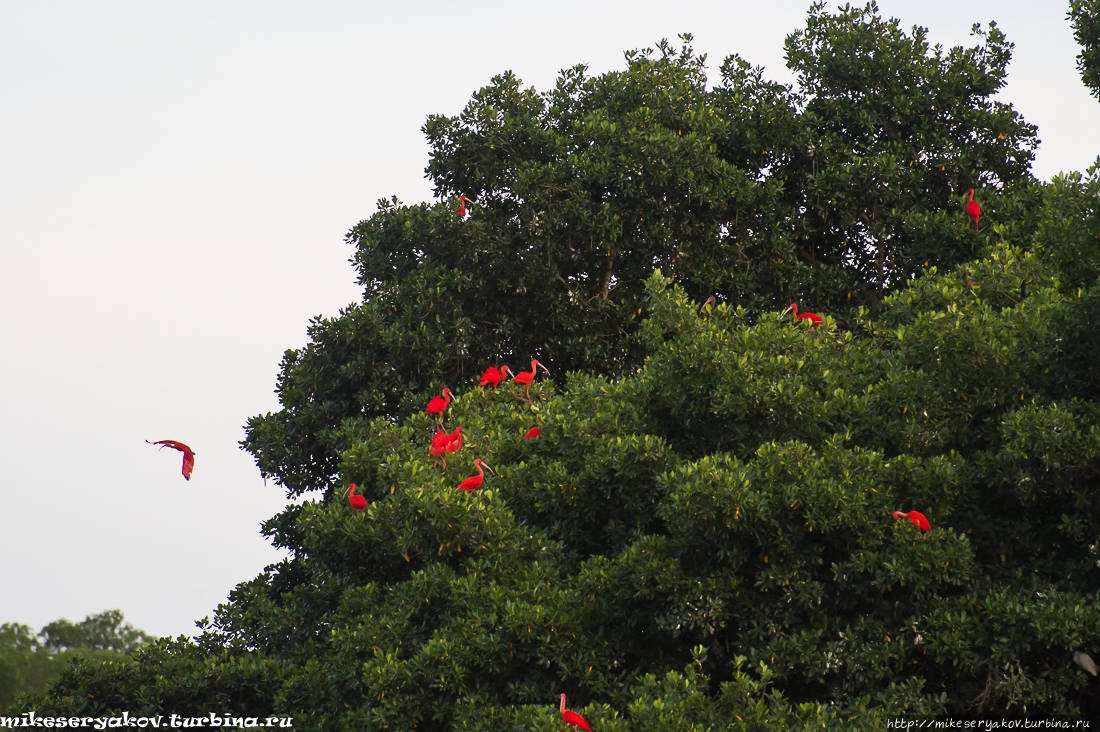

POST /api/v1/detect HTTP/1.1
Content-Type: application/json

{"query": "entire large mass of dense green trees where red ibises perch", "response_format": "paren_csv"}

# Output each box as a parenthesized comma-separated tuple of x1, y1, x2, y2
(21, 6, 1100, 731)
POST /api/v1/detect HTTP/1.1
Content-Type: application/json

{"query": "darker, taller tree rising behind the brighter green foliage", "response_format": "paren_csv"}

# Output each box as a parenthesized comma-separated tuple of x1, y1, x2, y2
(243, 4, 1036, 495)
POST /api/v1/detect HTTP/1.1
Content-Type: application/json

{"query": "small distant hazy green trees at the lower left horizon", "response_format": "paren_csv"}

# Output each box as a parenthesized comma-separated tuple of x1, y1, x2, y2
(0, 610, 155, 710)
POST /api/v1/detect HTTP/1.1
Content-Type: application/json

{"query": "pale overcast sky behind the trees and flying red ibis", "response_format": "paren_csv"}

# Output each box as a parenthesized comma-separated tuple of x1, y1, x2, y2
(0, 0, 1100, 635)
